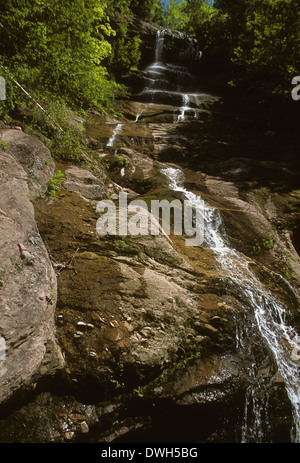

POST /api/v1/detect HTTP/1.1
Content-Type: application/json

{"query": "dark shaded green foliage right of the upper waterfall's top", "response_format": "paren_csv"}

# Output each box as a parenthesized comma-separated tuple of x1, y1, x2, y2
(165, 0, 300, 99)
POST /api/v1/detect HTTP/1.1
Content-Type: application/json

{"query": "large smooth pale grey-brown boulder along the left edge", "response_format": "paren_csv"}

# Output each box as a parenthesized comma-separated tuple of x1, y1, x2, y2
(0, 126, 63, 403)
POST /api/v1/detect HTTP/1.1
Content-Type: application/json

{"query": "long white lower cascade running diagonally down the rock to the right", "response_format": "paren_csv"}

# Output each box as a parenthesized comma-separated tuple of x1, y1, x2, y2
(163, 168, 300, 443)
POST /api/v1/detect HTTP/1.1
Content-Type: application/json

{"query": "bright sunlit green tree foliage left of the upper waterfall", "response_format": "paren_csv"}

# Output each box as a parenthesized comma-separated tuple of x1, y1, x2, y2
(0, 0, 130, 116)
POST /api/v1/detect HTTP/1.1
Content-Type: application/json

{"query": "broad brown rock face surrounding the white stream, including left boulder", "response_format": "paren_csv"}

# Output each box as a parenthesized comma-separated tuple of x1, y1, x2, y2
(0, 25, 300, 442)
